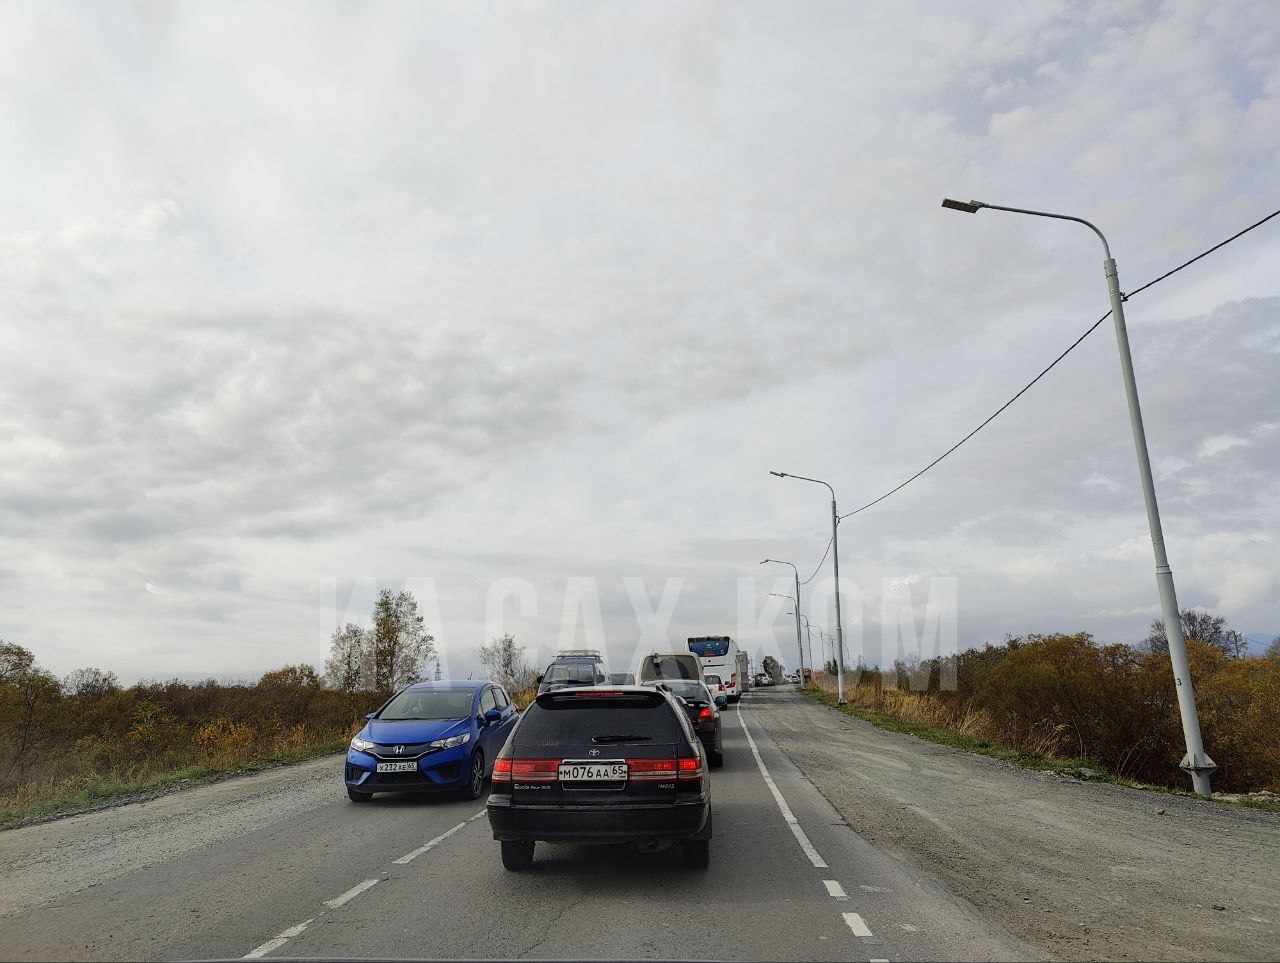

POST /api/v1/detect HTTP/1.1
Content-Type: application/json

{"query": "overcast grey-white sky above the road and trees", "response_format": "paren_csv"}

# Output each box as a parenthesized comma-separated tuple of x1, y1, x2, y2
(0, 0, 1280, 679)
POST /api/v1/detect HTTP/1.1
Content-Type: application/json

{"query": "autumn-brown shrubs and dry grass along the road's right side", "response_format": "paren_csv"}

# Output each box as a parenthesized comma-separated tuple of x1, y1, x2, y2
(817, 633, 1280, 791)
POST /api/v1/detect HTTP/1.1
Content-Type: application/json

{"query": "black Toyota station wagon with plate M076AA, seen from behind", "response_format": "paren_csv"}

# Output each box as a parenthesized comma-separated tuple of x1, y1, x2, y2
(486, 685, 712, 870)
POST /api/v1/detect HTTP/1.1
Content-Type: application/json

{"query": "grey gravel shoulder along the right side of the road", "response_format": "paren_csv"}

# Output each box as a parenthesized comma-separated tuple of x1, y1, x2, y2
(753, 692, 1280, 960)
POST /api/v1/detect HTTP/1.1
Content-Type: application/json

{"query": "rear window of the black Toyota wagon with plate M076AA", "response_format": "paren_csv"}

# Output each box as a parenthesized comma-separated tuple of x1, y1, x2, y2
(513, 697, 680, 747)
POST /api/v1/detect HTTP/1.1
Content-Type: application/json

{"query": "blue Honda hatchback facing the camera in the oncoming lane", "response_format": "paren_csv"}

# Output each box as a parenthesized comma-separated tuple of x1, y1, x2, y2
(346, 681, 520, 803)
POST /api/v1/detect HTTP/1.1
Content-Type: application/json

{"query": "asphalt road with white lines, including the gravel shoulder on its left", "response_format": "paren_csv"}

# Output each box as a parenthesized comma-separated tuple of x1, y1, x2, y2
(0, 690, 1042, 960)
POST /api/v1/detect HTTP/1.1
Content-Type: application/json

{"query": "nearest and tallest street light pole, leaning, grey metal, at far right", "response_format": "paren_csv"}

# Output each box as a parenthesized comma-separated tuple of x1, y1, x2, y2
(942, 197, 1217, 795)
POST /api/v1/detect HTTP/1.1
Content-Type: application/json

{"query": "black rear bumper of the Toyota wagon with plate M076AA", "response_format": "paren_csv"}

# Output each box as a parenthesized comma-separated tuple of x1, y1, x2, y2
(485, 797, 712, 843)
